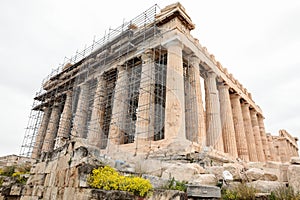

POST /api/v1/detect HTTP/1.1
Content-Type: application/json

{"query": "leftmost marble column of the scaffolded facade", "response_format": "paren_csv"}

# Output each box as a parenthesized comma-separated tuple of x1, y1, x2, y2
(31, 107, 51, 159)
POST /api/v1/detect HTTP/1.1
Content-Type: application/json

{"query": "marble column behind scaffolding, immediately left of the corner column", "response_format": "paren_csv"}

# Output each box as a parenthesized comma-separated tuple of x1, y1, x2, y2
(136, 50, 155, 141)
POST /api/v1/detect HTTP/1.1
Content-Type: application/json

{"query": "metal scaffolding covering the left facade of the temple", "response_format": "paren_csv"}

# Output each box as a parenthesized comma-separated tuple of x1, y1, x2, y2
(20, 5, 167, 157)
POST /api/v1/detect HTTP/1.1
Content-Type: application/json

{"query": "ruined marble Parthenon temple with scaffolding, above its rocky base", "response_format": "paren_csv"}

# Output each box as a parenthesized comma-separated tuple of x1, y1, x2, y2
(21, 3, 298, 162)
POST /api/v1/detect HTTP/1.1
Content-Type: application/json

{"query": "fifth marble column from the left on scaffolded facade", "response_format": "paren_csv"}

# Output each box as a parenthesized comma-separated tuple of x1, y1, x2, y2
(87, 75, 106, 148)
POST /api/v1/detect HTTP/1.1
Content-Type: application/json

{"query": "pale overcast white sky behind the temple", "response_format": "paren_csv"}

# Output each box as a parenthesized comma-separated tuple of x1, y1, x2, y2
(0, 0, 300, 156)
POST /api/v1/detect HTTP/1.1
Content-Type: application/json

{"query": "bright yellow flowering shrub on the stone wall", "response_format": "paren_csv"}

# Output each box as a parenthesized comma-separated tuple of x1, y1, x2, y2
(88, 166, 152, 197)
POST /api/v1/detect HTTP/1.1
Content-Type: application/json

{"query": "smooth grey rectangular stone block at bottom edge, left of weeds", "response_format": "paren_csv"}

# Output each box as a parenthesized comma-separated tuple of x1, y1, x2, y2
(186, 185, 221, 198)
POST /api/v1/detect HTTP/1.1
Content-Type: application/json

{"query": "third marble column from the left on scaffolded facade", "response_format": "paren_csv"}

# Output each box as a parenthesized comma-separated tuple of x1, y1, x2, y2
(55, 91, 72, 149)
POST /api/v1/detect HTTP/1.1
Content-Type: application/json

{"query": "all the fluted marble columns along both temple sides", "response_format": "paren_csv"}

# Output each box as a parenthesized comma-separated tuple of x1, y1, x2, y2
(32, 39, 296, 162)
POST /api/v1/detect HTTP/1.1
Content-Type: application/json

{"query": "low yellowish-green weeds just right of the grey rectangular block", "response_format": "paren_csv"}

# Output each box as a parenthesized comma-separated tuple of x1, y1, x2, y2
(222, 184, 258, 200)
